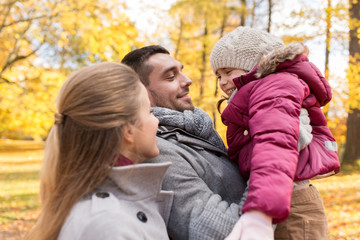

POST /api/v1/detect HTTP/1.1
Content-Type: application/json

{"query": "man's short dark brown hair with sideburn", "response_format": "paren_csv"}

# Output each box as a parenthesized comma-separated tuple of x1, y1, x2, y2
(121, 45, 170, 86)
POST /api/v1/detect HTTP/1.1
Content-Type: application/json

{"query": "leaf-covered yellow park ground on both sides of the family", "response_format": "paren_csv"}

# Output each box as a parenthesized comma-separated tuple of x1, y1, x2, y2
(0, 139, 360, 240)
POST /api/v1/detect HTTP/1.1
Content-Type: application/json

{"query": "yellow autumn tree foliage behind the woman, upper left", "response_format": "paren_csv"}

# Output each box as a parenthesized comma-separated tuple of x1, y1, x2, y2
(0, 0, 138, 138)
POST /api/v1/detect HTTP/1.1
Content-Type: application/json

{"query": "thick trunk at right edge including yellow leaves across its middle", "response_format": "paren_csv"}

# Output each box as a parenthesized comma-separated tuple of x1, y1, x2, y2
(343, 0, 360, 164)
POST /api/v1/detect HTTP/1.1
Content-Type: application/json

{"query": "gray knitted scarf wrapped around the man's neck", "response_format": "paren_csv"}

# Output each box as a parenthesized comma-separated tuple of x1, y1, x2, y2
(151, 107, 227, 151)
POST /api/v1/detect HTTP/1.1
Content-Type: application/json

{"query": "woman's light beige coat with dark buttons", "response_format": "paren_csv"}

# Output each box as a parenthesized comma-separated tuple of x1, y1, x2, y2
(58, 163, 173, 240)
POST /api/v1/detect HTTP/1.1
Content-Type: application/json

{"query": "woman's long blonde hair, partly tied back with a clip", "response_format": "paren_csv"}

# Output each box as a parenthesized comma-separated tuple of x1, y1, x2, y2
(27, 63, 141, 240)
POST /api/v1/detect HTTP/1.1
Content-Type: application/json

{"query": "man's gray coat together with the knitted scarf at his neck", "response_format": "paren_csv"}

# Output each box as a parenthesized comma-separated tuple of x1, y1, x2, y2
(148, 107, 245, 240)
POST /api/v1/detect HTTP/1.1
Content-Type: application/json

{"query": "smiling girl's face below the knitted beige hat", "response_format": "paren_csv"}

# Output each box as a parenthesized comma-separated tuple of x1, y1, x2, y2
(216, 68, 247, 97)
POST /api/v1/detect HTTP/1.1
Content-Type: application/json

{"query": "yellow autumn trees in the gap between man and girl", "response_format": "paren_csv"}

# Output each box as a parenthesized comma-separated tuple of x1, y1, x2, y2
(169, 0, 267, 140)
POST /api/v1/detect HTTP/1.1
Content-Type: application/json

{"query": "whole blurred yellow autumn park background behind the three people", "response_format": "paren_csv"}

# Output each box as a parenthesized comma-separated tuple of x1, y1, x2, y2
(0, 0, 360, 239)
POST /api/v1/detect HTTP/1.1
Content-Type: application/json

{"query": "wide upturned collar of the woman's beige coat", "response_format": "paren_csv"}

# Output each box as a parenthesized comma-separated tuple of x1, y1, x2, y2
(97, 162, 171, 200)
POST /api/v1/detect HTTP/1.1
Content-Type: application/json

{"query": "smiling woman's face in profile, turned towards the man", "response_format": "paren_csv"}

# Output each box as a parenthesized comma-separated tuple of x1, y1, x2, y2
(134, 84, 159, 162)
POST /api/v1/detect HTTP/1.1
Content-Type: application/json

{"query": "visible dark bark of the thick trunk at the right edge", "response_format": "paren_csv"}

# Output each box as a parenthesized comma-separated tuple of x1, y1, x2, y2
(343, 0, 360, 164)
